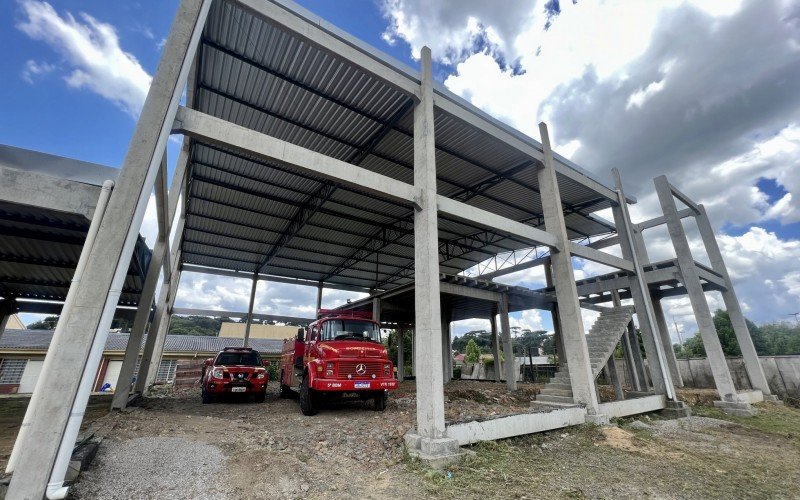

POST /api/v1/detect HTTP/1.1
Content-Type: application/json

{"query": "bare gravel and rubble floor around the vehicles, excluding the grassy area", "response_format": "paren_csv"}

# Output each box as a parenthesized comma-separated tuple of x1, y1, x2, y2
(74, 381, 538, 499)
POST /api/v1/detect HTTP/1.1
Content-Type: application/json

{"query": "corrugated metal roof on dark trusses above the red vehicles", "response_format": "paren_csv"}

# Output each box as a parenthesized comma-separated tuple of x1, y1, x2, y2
(182, 1, 614, 289)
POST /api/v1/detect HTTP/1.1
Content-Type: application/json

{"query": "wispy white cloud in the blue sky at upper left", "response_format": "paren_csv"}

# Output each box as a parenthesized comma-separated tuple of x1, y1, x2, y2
(17, 0, 151, 117)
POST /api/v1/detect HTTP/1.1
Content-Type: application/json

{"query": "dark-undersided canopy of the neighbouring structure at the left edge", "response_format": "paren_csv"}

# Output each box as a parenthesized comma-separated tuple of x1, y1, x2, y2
(0, 145, 150, 313)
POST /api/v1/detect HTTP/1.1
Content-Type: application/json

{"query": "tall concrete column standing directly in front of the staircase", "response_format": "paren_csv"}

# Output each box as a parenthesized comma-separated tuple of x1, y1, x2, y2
(538, 123, 598, 414)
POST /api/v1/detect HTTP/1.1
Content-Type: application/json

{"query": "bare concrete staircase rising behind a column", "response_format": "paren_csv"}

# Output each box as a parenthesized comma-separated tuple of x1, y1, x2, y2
(536, 306, 634, 404)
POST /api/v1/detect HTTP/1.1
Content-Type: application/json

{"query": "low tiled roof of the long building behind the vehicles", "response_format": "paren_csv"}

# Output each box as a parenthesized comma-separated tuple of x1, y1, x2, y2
(0, 330, 283, 354)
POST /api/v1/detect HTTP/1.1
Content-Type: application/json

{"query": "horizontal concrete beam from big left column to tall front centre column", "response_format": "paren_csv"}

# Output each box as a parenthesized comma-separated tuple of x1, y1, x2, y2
(173, 107, 420, 205)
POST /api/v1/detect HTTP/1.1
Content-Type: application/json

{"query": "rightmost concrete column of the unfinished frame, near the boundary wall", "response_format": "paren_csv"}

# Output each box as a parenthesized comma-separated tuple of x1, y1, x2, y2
(696, 205, 772, 396)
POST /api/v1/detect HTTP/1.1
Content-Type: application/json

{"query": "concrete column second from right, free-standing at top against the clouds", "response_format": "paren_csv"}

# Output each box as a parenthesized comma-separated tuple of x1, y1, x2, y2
(655, 176, 738, 401)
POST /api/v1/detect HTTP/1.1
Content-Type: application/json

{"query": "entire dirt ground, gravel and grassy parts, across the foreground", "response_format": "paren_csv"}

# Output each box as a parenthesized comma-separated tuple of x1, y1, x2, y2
(1, 381, 800, 499)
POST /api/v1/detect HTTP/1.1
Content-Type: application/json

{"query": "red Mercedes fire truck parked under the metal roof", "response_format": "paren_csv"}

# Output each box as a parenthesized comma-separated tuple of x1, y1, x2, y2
(280, 309, 397, 415)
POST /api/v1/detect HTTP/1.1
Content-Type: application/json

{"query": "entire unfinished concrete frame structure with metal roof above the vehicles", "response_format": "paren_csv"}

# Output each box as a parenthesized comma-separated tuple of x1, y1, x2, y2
(9, 0, 780, 498)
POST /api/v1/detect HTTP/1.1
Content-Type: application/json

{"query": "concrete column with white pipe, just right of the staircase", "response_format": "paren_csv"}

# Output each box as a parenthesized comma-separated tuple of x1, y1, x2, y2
(612, 169, 675, 400)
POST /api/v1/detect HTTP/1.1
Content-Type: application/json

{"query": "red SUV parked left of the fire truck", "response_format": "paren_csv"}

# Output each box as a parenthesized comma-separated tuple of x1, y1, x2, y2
(200, 347, 269, 404)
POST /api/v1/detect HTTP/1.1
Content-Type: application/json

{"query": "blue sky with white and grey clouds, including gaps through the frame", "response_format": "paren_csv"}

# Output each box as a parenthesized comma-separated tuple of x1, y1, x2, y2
(0, 0, 800, 338)
